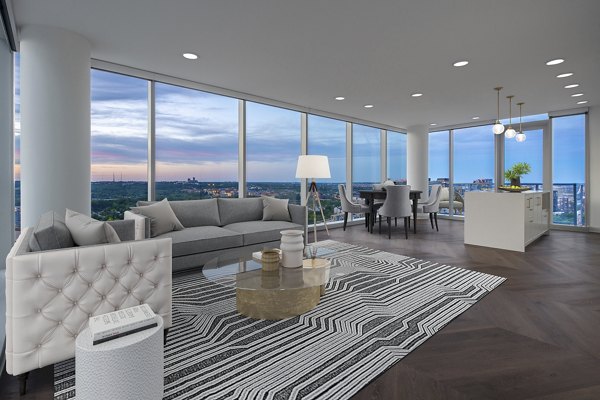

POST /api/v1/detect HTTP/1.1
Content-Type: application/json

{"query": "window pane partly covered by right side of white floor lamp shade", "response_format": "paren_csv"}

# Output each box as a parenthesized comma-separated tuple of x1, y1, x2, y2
(308, 115, 346, 221)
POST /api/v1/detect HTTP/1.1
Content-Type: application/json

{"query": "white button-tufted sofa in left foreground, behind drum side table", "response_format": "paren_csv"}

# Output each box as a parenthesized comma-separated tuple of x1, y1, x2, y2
(6, 228, 172, 390)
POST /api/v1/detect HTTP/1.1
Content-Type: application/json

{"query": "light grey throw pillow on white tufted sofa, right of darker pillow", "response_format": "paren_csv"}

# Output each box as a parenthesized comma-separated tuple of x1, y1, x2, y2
(65, 209, 121, 246)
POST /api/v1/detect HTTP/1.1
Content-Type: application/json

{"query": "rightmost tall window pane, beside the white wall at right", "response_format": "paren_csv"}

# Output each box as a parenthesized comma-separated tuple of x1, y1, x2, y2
(552, 114, 586, 226)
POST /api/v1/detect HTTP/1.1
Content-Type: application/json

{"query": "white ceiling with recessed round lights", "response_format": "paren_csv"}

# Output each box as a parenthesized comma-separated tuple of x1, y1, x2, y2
(13, 0, 600, 127)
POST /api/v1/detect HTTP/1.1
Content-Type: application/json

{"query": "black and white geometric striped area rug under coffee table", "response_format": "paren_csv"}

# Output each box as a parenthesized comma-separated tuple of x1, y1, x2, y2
(54, 240, 504, 400)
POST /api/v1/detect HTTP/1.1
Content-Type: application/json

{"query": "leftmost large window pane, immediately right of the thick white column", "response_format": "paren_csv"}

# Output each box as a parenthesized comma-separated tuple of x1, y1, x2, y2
(91, 70, 148, 220)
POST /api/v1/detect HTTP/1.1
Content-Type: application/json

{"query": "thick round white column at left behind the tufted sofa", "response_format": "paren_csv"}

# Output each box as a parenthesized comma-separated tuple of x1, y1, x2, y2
(20, 26, 91, 227)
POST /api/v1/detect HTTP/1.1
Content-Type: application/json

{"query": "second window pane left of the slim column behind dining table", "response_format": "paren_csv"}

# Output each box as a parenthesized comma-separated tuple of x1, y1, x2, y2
(352, 124, 381, 208)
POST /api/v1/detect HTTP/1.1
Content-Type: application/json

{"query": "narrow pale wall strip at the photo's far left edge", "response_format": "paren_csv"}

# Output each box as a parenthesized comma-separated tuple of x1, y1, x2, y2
(0, 39, 15, 260)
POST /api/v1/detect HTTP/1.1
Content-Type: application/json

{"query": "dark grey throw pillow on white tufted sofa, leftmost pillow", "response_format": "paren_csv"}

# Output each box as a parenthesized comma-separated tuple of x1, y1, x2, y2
(29, 211, 75, 251)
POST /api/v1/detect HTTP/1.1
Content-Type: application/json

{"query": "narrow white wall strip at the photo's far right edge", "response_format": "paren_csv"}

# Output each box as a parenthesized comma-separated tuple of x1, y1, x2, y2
(588, 106, 600, 232)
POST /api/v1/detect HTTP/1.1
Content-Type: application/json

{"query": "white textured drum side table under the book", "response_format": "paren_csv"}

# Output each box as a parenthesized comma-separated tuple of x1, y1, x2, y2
(75, 315, 164, 400)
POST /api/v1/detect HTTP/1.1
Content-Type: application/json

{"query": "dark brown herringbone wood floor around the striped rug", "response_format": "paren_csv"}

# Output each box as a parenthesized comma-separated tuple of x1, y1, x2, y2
(0, 220, 600, 400)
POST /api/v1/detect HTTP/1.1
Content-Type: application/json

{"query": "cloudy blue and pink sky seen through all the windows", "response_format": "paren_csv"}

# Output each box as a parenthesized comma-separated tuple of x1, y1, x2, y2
(15, 58, 585, 183)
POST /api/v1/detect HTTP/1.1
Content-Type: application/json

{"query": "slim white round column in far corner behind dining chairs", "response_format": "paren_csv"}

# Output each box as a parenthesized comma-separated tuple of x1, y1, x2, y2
(406, 125, 429, 194)
